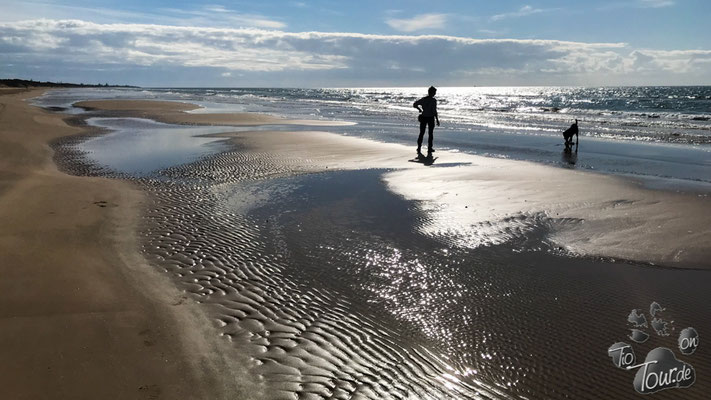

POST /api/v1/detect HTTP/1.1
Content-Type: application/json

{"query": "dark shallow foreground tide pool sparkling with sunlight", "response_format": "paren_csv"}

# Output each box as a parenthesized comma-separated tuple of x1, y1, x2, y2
(220, 171, 711, 398)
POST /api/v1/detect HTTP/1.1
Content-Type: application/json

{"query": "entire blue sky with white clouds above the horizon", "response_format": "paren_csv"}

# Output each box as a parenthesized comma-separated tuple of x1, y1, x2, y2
(0, 0, 711, 87)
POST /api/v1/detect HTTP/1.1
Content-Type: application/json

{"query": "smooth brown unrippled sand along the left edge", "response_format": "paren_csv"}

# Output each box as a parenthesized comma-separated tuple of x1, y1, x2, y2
(0, 91, 260, 399)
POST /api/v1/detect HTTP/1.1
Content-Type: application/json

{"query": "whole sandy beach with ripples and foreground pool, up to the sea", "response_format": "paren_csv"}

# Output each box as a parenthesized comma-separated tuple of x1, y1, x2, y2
(0, 92, 711, 399)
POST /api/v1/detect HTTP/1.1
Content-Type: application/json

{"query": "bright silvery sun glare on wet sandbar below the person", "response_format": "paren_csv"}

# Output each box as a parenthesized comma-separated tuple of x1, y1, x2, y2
(383, 164, 544, 249)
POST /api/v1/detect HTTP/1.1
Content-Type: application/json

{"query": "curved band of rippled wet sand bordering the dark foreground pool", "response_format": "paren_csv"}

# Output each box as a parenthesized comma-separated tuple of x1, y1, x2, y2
(135, 151, 502, 399)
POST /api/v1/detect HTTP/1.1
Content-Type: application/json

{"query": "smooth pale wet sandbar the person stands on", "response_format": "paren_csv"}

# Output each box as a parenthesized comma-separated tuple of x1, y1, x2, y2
(216, 131, 711, 269)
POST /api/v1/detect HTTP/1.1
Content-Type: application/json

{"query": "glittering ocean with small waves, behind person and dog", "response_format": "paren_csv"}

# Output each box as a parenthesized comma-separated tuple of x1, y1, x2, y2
(36, 86, 711, 192)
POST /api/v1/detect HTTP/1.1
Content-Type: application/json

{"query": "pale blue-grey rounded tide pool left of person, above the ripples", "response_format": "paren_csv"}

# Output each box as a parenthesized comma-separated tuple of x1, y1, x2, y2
(78, 118, 239, 175)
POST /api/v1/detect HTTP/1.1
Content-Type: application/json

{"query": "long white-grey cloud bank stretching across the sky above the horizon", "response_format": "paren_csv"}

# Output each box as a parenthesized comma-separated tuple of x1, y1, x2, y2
(0, 20, 711, 86)
